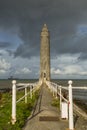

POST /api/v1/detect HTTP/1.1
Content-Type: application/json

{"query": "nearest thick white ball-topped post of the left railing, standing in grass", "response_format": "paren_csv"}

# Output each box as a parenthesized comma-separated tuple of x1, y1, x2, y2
(11, 80, 16, 125)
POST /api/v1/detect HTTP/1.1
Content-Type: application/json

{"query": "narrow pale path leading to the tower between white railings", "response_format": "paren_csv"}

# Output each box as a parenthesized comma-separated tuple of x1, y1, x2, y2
(23, 84, 68, 130)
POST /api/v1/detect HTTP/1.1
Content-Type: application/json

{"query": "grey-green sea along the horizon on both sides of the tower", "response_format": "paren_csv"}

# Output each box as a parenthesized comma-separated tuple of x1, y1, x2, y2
(0, 79, 87, 104)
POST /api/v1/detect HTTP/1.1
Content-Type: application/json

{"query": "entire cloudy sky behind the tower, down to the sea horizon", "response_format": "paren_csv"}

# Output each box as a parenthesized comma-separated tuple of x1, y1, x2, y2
(0, 0, 87, 79)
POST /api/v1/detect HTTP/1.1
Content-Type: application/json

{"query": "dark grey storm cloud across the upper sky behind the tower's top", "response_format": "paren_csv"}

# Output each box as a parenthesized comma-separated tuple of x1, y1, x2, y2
(0, 0, 87, 58)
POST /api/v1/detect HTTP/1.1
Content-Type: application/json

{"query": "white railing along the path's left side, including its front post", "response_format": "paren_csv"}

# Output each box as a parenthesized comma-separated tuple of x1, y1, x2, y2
(11, 80, 42, 125)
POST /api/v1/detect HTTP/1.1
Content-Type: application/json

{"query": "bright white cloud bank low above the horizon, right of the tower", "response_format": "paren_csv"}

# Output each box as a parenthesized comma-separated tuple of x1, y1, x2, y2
(51, 54, 87, 78)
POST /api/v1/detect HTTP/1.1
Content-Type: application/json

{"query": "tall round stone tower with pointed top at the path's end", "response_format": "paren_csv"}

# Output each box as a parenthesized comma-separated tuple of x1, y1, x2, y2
(40, 24, 50, 81)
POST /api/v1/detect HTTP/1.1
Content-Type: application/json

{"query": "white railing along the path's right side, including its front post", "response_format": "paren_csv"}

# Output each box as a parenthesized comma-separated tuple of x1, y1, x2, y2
(46, 80, 87, 130)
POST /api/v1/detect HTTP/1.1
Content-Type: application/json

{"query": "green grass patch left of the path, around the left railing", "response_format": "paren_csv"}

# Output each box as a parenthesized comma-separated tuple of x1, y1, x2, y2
(0, 91, 39, 130)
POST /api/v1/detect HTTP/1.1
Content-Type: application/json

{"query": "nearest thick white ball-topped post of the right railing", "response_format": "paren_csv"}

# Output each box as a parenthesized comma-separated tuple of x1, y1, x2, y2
(68, 80, 74, 130)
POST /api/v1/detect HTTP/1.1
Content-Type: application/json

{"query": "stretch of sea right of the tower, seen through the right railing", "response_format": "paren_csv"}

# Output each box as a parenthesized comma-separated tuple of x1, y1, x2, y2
(53, 79, 87, 105)
